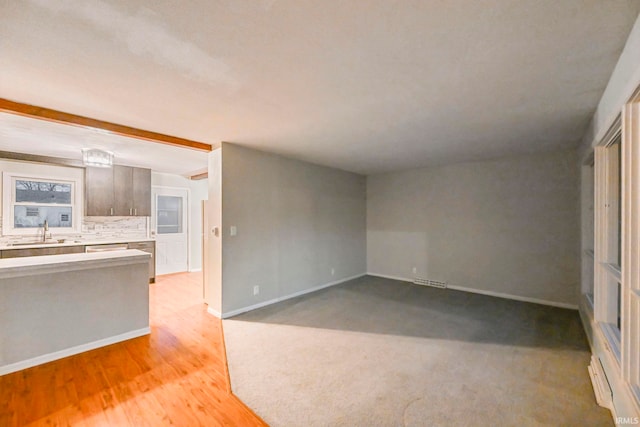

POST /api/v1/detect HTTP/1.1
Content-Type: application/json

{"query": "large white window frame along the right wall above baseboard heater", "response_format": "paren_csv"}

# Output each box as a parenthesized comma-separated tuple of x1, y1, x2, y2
(594, 89, 640, 409)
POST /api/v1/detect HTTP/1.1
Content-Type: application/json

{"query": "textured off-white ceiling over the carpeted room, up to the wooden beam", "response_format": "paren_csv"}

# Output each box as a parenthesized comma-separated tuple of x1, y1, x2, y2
(0, 0, 640, 173)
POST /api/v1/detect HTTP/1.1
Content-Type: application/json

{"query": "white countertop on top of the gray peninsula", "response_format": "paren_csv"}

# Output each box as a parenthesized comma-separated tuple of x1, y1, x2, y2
(0, 249, 151, 278)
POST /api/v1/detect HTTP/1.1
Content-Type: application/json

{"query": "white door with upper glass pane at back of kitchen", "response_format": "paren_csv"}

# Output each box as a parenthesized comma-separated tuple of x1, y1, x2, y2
(152, 187, 189, 275)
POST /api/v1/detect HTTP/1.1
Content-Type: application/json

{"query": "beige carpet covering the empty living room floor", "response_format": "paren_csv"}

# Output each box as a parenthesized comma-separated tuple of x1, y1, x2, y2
(223, 277, 613, 427)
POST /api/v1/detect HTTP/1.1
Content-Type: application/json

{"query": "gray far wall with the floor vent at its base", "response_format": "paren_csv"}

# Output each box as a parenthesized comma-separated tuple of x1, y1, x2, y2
(367, 151, 580, 305)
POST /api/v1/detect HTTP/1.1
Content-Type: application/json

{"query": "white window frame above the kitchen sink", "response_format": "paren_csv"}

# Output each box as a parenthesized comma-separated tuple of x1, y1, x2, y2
(2, 172, 83, 236)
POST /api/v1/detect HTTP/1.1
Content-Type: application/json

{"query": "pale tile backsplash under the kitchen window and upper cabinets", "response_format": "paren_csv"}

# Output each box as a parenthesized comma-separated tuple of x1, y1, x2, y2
(0, 216, 149, 245)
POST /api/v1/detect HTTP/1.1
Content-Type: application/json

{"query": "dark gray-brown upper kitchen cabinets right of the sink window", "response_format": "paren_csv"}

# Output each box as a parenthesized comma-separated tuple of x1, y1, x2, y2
(85, 165, 151, 216)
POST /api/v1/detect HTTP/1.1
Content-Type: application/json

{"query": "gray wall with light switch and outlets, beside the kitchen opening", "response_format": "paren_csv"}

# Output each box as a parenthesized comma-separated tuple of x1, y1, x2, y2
(222, 143, 366, 314)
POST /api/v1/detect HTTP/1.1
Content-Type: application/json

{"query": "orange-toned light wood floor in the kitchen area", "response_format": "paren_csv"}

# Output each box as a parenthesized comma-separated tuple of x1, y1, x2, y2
(0, 273, 266, 427)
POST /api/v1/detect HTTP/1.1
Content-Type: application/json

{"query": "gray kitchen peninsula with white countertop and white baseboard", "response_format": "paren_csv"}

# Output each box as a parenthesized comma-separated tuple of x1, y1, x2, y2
(0, 249, 151, 375)
